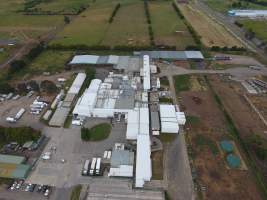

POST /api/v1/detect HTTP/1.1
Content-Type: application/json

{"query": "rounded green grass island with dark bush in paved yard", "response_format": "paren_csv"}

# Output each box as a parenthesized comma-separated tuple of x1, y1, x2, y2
(81, 123, 111, 141)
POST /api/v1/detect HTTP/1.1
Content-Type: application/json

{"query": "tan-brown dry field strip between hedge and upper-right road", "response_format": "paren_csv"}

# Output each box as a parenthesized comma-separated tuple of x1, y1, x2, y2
(179, 4, 242, 47)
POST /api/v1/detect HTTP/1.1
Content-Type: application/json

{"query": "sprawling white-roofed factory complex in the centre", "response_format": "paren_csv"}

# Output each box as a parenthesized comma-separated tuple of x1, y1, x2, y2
(72, 54, 187, 188)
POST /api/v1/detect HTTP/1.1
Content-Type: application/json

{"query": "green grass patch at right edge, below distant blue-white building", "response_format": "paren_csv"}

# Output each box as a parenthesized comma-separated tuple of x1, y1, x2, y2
(240, 20, 267, 42)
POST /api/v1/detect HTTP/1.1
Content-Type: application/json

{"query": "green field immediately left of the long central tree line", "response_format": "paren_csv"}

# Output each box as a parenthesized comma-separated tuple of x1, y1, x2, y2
(101, 1, 149, 46)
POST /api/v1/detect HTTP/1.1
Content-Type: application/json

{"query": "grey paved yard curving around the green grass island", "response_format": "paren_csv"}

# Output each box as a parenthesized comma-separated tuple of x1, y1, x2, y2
(26, 119, 126, 188)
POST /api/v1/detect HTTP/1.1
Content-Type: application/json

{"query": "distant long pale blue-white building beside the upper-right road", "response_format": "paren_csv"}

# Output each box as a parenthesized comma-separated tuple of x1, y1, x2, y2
(228, 10, 267, 18)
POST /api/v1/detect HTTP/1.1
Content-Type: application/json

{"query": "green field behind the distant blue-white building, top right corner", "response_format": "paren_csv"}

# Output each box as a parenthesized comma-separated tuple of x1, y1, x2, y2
(205, 0, 267, 13)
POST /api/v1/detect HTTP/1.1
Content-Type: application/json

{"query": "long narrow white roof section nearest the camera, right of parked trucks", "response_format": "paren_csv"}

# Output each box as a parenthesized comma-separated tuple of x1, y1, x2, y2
(135, 135, 152, 187)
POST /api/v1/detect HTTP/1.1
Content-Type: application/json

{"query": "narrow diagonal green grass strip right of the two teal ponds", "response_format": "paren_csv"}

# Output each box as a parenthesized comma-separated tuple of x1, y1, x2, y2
(205, 76, 267, 198)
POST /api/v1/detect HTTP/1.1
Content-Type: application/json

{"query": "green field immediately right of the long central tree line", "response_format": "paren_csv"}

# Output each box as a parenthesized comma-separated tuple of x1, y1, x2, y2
(149, 1, 194, 50)
